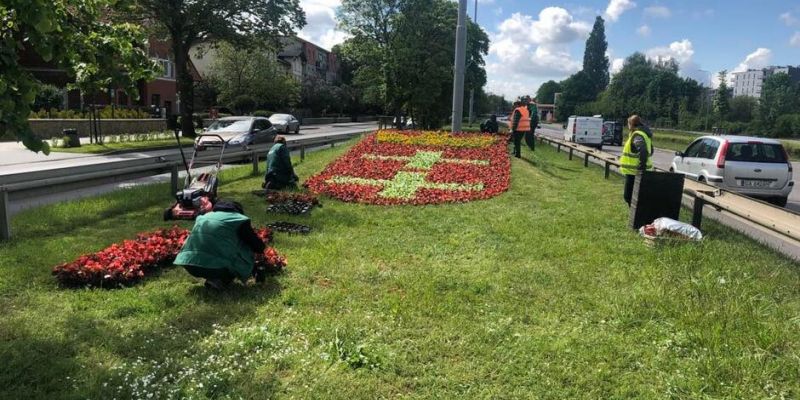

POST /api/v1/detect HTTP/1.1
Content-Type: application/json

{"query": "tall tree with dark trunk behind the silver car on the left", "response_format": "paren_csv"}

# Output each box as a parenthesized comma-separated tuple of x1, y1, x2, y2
(137, 0, 306, 136)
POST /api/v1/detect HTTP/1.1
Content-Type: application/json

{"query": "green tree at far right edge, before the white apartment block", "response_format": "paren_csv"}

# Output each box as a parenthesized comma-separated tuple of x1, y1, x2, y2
(759, 73, 800, 134)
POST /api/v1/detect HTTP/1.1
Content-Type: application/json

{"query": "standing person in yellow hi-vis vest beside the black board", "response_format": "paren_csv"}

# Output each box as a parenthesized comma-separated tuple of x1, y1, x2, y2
(619, 115, 653, 206)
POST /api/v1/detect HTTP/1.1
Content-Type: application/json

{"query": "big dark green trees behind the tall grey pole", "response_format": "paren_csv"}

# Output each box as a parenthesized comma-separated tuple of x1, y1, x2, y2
(334, 0, 496, 128)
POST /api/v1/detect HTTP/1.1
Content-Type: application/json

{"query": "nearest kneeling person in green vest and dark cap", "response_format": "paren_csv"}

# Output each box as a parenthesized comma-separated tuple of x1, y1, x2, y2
(174, 200, 265, 290)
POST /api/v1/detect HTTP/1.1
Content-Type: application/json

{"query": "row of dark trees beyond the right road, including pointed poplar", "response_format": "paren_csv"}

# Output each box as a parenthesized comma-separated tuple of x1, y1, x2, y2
(536, 17, 800, 137)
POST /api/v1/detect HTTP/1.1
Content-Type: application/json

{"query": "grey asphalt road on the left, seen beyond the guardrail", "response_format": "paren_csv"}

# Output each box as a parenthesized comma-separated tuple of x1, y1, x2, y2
(0, 122, 377, 215)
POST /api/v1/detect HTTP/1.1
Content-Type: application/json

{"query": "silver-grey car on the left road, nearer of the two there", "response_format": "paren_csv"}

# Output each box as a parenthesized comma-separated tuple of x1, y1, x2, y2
(195, 117, 277, 148)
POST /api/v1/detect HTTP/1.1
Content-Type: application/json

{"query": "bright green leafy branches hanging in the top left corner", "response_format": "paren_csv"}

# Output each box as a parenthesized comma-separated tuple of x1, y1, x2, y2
(0, 0, 155, 154)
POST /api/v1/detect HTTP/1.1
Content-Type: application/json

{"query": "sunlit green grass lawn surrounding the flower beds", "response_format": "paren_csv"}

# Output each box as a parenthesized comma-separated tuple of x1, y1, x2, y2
(0, 138, 800, 400)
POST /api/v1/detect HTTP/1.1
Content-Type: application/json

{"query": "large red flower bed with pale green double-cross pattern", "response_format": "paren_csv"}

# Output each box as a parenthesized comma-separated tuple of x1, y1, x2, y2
(305, 131, 511, 204)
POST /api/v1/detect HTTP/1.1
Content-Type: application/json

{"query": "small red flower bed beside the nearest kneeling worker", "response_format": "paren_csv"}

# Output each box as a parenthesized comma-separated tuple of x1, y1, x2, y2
(53, 227, 286, 288)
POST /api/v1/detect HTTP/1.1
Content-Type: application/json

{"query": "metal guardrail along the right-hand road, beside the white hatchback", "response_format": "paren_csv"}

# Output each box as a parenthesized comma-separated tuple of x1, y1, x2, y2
(537, 135, 800, 246)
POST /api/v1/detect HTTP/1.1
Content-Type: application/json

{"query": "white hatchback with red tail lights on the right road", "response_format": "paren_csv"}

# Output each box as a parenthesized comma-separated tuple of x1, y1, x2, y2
(670, 136, 794, 207)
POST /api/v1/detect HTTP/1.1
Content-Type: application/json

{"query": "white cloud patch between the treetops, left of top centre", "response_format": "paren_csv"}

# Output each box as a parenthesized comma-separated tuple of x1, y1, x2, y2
(297, 0, 347, 50)
